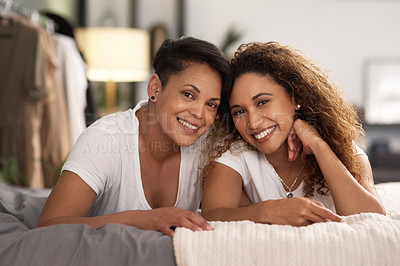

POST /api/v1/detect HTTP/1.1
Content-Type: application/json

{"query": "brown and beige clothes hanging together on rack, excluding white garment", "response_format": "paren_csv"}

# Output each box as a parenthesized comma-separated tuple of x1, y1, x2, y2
(0, 1, 71, 188)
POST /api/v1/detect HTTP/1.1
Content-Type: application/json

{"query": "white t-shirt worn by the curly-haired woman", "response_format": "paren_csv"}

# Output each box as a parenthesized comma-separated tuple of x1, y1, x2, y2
(216, 140, 365, 212)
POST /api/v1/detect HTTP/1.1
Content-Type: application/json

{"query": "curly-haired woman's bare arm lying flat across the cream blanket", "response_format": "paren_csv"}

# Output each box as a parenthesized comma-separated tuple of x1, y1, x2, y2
(202, 163, 342, 226)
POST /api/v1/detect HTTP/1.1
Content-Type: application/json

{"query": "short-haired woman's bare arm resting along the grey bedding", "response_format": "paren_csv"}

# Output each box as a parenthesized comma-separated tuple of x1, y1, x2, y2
(36, 171, 211, 236)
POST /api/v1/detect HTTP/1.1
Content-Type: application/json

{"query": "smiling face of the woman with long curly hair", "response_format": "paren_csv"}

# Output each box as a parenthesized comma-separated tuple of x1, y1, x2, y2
(229, 73, 295, 155)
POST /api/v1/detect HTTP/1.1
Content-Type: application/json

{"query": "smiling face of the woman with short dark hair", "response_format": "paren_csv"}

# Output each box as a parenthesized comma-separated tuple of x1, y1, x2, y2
(149, 63, 221, 146)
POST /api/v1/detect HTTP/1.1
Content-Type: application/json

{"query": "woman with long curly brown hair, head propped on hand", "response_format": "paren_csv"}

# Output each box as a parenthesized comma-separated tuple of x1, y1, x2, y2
(202, 42, 385, 226)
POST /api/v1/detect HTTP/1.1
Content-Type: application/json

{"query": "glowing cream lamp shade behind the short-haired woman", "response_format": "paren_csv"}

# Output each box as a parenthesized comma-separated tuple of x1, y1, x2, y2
(76, 27, 150, 82)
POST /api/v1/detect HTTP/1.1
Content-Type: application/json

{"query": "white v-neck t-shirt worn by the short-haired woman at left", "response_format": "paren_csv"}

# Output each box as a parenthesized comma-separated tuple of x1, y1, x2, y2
(62, 101, 205, 216)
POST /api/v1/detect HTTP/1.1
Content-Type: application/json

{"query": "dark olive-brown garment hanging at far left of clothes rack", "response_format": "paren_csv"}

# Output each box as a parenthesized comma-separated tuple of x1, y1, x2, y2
(0, 14, 47, 187)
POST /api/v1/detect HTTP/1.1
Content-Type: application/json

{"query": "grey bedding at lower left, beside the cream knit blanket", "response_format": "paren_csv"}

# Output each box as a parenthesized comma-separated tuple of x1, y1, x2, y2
(0, 183, 175, 266)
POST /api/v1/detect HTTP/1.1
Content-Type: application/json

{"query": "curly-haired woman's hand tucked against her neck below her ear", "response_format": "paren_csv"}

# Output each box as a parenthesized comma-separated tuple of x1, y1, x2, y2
(288, 119, 325, 160)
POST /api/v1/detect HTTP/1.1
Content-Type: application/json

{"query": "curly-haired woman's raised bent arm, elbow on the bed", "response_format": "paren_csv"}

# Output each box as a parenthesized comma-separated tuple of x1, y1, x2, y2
(294, 120, 385, 215)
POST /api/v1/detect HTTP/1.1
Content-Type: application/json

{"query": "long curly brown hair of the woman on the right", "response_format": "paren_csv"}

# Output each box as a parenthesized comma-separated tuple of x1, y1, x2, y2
(202, 42, 364, 197)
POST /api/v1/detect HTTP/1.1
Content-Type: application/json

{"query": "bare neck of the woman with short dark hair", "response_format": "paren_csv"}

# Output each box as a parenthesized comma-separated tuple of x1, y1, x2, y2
(136, 108, 180, 161)
